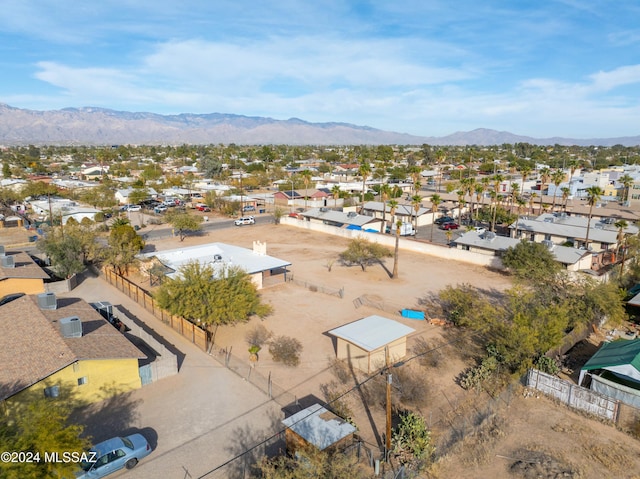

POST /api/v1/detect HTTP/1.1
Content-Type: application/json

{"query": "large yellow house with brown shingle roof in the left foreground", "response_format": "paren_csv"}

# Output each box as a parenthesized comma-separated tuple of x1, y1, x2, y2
(0, 293, 145, 407)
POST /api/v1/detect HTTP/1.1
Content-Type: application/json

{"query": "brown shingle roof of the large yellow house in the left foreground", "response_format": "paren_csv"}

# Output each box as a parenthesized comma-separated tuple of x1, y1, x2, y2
(0, 295, 145, 400)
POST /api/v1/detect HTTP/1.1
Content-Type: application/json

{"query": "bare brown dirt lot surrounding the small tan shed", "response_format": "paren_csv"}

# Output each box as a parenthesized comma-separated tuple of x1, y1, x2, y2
(131, 225, 640, 478)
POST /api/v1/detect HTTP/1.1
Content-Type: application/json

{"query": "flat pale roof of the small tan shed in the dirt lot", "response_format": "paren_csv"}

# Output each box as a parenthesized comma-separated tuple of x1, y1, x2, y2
(329, 315, 415, 352)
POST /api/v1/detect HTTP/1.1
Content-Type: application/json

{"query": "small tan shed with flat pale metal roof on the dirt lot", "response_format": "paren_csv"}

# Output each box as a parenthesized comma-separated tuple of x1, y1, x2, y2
(329, 315, 415, 373)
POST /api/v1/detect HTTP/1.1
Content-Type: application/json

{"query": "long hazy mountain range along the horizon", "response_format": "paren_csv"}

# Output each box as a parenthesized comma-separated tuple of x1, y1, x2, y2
(0, 103, 640, 146)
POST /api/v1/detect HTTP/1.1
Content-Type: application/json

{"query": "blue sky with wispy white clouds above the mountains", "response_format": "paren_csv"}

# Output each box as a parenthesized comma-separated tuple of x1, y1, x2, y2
(0, 0, 640, 138)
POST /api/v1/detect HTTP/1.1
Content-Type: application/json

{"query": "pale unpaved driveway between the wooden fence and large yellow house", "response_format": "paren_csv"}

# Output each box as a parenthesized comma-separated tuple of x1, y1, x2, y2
(64, 278, 282, 479)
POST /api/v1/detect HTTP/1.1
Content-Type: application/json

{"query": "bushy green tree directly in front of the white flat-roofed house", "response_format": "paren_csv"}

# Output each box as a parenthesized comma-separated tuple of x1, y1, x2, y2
(155, 261, 271, 327)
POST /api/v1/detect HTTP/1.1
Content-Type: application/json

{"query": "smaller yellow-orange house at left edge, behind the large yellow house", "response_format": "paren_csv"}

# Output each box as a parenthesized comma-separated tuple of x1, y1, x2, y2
(0, 251, 49, 298)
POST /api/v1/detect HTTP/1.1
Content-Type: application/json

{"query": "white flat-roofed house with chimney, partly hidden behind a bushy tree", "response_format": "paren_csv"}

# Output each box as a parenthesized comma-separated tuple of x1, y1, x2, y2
(139, 241, 291, 289)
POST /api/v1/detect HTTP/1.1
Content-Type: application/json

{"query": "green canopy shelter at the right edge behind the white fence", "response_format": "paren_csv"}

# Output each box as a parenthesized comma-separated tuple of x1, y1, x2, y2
(578, 339, 640, 405)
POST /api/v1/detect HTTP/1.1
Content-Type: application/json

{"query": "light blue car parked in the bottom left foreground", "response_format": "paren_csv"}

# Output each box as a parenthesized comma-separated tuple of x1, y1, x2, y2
(76, 434, 151, 479)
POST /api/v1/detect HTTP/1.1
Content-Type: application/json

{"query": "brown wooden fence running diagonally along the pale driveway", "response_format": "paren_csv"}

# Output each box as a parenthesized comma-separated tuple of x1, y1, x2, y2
(102, 268, 209, 351)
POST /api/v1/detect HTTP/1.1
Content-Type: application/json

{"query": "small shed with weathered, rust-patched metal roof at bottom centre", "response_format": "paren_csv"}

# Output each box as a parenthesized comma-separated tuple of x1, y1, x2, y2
(282, 404, 356, 454)
